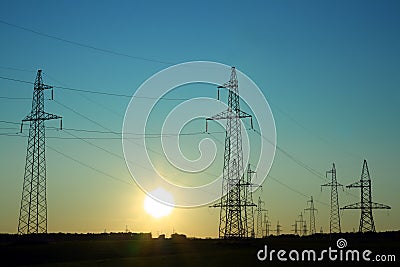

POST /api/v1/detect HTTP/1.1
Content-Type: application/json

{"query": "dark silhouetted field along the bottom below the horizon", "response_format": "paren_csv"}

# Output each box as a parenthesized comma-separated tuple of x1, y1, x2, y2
(0, 232, 400, 266)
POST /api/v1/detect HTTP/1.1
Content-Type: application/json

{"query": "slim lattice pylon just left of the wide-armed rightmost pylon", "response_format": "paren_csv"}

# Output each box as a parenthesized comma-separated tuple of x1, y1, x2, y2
(321, 163, 343, 234)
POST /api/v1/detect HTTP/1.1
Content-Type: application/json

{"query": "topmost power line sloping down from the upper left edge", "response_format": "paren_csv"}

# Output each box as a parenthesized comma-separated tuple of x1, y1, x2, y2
(0, 20, 175, 65)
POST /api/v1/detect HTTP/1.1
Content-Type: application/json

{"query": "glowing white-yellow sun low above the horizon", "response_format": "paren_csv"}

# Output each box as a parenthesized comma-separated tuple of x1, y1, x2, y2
(144, 189, 173, 219)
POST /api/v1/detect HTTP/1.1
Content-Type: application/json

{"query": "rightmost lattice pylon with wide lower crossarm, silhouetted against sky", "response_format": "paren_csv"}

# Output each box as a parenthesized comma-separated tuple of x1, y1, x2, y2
(342, 160, 391, 232)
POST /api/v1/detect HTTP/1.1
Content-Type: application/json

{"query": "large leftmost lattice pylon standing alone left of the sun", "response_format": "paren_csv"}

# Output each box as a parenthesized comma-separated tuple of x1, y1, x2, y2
(18, 70, 62, 234)
